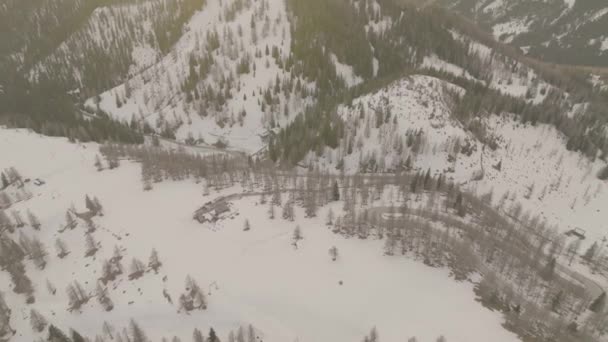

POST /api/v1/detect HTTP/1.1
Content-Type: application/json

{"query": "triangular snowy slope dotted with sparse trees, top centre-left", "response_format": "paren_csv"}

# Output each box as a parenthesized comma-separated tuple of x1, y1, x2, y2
(87, 0, 308, 152)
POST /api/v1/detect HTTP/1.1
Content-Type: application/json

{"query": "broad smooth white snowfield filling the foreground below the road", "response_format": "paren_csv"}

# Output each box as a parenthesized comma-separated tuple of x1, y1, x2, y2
(0, 129, 517, 342)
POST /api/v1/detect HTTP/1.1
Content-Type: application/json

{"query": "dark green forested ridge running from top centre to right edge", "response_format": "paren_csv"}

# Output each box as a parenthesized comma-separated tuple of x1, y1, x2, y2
(269, 0, 608, 164)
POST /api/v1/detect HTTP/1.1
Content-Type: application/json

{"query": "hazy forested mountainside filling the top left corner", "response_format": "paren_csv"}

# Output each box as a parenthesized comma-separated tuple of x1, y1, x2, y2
(0, 0, 205, 143)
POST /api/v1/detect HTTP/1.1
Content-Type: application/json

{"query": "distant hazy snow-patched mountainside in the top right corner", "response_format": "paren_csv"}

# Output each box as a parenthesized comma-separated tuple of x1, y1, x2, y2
(437, 0, 608, 67)
